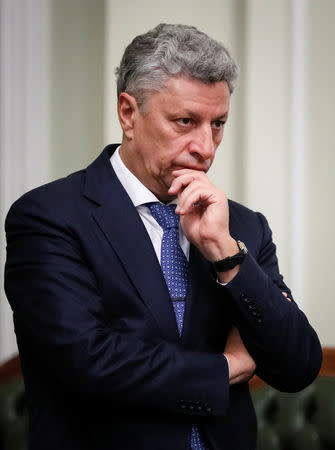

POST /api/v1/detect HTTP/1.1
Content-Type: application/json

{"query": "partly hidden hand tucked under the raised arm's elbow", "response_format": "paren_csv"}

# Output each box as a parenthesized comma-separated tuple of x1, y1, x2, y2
(224, 326, 256, 384)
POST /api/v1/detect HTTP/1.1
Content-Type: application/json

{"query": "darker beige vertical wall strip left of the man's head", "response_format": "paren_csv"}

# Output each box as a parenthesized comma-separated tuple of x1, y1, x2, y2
(50, 0, 105, 178)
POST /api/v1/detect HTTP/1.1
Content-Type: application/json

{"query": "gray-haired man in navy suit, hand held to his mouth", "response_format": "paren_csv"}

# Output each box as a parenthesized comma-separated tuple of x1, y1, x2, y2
(5, 25, 321, 450)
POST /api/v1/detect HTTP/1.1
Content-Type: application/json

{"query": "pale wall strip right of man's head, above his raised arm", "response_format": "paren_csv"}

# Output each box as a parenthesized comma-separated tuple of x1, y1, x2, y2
(240, 0, 292, 284)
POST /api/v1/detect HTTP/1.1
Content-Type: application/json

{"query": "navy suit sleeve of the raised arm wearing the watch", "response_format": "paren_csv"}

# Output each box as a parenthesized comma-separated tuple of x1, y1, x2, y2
(225, 213, 322, 392)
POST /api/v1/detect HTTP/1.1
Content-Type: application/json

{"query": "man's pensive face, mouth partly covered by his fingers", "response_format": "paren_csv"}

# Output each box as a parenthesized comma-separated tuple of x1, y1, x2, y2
(121, 77, 230, 201)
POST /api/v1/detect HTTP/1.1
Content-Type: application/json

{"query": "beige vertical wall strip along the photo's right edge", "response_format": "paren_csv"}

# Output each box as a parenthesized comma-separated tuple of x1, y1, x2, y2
(304, 0, 335, 345)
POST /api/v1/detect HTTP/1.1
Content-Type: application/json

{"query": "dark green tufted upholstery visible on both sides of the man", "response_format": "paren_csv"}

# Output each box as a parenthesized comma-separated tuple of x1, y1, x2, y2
(0, 376, 335, 450)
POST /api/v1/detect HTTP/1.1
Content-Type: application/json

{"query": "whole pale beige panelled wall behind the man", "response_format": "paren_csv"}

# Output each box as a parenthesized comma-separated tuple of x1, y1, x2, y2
(0, 0, 335, 359)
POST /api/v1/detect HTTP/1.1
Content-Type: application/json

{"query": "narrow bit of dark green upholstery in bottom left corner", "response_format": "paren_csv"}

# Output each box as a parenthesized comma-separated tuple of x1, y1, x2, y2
(0, 376, 28, 450)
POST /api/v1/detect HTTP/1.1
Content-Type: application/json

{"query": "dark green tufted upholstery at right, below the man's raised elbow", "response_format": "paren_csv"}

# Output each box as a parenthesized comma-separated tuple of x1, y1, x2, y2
(252, 377, 335, 450)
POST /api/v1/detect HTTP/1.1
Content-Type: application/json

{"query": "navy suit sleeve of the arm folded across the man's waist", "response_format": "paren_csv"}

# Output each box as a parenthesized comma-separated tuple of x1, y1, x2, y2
(5, 195, 229, 415)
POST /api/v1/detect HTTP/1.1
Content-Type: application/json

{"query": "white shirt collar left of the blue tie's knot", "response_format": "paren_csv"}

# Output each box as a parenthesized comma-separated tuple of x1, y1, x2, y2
(110, 146, 177, 207)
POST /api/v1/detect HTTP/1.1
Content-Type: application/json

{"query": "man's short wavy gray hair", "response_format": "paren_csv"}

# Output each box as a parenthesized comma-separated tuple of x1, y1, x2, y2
(115, 24, 238, 108)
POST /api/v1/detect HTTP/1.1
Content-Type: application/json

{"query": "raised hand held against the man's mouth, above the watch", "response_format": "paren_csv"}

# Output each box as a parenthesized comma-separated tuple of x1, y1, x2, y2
(169, 169, 239, 262)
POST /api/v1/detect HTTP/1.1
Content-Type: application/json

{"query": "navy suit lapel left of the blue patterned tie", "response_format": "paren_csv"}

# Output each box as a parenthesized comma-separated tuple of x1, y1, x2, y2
(84, 146, 178, 341)
